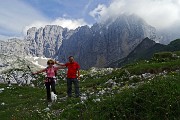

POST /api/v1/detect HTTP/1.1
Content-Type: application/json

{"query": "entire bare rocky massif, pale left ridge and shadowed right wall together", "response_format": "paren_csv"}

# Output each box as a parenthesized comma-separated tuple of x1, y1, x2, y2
(0, 15, 156, 69)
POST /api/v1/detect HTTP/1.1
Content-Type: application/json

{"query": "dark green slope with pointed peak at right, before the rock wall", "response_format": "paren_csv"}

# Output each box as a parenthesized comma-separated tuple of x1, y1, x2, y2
(108, 38, 180, 67)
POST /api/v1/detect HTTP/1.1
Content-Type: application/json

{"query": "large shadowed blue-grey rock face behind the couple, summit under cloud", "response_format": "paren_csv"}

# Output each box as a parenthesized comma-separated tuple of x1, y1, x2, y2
(58, 15, 156, 69)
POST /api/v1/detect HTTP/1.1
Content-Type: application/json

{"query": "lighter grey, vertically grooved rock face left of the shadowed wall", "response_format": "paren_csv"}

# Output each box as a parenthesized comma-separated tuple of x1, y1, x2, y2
(25, 25, 67, 57)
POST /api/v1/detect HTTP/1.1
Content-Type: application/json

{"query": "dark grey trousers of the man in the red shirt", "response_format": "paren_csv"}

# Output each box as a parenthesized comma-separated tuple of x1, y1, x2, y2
(67, 78, 79, 97)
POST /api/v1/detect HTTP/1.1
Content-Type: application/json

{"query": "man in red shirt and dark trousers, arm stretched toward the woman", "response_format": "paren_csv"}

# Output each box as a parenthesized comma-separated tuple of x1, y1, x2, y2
(56, 56, 80, 97)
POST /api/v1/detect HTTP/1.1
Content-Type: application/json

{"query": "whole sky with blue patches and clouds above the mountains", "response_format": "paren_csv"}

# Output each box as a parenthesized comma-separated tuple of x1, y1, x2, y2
(0, 0, 180, 39)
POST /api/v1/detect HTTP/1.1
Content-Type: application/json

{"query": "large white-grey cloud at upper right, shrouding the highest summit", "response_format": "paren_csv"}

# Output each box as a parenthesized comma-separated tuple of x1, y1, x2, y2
(89, 0, 180, 29)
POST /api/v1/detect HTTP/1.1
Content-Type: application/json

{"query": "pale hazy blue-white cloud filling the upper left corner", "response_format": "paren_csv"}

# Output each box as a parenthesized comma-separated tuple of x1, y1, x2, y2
(0, 0, 47, 35)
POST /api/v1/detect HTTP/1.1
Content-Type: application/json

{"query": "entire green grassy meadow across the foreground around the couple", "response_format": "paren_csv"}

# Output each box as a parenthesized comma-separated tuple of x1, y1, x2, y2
(0, 53, 180, 120)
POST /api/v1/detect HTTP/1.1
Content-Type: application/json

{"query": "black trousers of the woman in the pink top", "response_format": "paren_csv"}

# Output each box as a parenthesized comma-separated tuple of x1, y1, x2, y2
(45, 78, 56, 101)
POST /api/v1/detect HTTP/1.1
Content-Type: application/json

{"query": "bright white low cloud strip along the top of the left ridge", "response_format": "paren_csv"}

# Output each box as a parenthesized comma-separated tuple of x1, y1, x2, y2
(23, 18, 90, 33)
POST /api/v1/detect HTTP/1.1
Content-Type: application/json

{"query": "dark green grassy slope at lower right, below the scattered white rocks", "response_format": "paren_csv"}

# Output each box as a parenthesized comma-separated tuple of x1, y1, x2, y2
(61, 74, 180, 120)
